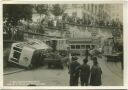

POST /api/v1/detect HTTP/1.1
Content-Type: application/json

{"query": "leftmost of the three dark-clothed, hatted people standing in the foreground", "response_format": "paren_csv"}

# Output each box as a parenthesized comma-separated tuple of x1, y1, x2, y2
(69, 56, 80, 86)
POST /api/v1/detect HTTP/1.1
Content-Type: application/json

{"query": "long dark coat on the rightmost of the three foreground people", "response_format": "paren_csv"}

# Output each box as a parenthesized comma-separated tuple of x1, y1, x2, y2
(90, 65, 102, 86)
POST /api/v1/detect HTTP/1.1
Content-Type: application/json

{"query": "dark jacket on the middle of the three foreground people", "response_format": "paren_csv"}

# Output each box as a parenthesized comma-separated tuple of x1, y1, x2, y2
(80, 64, 90, 82)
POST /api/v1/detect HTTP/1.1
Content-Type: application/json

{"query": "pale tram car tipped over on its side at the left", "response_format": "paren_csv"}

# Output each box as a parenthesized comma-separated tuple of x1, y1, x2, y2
(8, 40, 52, 69)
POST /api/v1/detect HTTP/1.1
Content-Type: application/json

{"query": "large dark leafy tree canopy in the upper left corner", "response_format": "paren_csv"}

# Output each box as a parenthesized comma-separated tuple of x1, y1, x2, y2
(3, 4, 33, 26)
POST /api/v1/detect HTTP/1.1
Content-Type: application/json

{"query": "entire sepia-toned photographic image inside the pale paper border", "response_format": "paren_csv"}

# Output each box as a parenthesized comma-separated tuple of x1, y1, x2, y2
(3, 3, 124, 86)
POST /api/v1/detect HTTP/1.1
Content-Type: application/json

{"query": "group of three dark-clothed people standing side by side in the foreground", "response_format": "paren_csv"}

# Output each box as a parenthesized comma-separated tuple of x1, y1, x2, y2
(69, 53, 102, 86)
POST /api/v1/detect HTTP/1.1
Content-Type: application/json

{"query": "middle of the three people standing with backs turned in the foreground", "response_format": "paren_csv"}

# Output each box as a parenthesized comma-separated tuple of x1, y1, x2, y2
(80, 58, 90, 86)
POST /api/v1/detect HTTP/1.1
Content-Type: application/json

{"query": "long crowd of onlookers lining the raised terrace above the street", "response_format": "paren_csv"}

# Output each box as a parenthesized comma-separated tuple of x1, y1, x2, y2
(4, 11, 122, 40)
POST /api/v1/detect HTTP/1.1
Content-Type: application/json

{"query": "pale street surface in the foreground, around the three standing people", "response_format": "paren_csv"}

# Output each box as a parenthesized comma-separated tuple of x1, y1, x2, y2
(4, 57, 123, 86)
